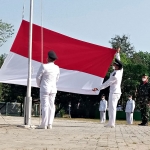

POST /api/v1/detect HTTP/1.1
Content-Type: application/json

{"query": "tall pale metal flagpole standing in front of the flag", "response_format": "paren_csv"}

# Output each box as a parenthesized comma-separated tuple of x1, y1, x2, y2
(24, 0, 33, 126)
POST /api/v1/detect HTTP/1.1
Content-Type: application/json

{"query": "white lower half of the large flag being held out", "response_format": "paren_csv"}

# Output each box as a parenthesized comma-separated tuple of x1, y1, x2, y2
(0, 52, 103, 95)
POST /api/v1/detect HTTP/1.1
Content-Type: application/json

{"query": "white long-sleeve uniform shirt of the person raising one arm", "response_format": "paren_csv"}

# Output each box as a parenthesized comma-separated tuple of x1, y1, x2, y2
(100, 53, 123, 94)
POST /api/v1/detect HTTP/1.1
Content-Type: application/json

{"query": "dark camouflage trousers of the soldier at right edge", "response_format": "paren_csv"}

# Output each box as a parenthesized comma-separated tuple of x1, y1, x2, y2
(140, 104, 149, 124)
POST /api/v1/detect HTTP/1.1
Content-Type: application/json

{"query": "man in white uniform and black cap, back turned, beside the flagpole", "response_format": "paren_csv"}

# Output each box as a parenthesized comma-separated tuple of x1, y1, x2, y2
(36, 51, 60, 129)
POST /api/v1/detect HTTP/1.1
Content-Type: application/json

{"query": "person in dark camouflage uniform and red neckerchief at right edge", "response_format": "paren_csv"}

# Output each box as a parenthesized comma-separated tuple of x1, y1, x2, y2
(137, 73, 150, 126)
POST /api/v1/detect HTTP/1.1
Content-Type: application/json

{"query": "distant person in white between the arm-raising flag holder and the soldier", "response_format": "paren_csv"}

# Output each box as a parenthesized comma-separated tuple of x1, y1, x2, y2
(125, 95, 135, 124)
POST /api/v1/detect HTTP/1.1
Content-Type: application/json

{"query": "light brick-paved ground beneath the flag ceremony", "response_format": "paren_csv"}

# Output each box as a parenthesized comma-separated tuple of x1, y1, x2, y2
(0, 116, 150, 150)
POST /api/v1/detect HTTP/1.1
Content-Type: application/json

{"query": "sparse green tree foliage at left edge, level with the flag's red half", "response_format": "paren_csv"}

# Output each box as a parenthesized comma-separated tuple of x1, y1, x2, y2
(0, 20, 14, 46)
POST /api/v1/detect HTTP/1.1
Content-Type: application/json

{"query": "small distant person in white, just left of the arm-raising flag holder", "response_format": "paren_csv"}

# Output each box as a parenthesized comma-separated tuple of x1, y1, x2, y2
(99, 94, 107, 123)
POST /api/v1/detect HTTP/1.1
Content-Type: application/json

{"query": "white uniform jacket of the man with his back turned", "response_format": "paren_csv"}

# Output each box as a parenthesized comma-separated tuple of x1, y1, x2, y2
(36, 62, 60, 93)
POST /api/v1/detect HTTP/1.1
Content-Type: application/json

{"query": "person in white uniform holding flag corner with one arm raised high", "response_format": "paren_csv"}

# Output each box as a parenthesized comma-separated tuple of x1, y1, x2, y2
(93, 48, 123, 128)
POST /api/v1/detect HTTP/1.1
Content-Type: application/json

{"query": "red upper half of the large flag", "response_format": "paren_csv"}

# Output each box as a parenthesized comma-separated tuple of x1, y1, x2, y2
(11, 20, 116, 77)
